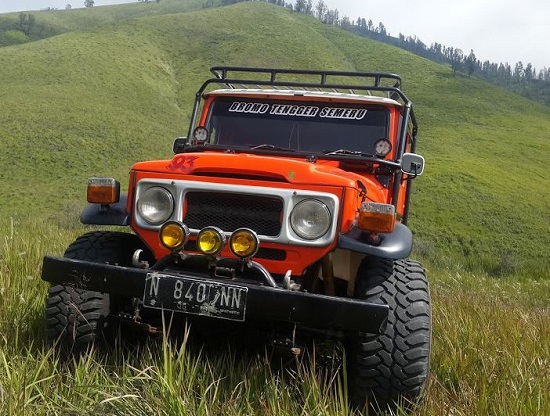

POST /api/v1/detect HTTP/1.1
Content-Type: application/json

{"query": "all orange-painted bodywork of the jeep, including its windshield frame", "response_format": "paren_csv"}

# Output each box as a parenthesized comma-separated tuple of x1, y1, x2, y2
(127, 85, 414, 275)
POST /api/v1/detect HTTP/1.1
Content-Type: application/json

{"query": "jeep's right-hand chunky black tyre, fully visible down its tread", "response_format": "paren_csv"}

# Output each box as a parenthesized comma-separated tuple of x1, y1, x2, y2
(347, 258, 431, 411)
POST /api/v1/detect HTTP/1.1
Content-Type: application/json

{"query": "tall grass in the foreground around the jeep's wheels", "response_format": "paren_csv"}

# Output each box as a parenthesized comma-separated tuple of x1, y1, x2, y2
(0, 219, 550, 415)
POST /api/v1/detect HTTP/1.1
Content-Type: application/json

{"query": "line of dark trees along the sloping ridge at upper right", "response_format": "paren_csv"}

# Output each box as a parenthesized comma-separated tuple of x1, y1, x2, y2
(204, 0, 550, 106)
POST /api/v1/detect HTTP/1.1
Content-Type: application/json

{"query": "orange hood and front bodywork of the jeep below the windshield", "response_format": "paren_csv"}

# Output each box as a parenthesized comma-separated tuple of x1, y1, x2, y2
(127, 152, 388, 274)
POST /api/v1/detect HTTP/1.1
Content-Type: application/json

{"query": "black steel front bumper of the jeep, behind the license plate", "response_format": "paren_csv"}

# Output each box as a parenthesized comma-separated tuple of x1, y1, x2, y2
(42, 256, 388, 333)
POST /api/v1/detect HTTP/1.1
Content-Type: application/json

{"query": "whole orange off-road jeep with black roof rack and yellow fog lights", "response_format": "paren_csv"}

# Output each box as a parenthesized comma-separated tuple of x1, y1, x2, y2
(42, 67, 431, 407)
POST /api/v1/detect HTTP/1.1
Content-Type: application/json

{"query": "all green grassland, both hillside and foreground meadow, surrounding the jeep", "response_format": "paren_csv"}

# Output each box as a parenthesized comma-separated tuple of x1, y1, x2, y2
(0, 0, 550, 415)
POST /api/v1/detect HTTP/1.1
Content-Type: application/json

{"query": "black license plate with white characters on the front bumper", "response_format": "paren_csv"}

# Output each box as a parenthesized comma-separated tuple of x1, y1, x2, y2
(143, 273, 248, 321)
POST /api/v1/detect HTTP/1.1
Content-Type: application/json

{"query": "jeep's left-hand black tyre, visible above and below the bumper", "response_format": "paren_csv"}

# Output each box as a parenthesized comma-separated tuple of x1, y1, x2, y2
(45, 231, 150, 353)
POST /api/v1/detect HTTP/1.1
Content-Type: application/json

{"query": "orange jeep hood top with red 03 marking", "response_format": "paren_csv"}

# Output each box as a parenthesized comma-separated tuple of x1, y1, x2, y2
(133, 152, 380, 196)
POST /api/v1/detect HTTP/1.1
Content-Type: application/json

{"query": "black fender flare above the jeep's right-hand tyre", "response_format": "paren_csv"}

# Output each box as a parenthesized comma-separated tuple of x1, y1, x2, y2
(338, 223, 413, 259)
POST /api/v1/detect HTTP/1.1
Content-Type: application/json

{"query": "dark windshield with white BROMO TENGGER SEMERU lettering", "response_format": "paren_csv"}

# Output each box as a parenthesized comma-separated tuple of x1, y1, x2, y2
(206, 97, 389, 154)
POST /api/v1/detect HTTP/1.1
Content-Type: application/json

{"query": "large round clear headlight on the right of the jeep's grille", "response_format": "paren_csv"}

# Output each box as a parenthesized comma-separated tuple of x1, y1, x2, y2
(290, 199, 331, 240)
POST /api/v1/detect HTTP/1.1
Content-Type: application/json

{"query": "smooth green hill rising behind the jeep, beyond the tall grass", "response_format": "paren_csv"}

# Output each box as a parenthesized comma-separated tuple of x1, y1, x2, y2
(0, 0, 550, 277)
